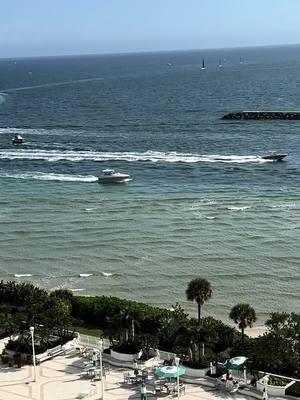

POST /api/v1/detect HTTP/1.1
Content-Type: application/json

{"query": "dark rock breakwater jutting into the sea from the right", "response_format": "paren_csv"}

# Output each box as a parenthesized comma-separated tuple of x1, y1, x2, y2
(222, 111, 300, 120)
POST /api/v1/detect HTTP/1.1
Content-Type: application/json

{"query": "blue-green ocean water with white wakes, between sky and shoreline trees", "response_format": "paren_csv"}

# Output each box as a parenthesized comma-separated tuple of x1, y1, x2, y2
(0, 46, 300, 321)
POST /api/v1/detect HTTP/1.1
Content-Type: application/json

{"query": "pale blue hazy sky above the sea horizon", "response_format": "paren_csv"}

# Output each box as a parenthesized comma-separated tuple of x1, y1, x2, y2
(0, 0, 300, 57)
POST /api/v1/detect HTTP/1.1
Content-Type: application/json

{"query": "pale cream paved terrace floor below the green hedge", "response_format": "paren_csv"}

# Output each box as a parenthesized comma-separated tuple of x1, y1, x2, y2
(0, 356, 262, 400)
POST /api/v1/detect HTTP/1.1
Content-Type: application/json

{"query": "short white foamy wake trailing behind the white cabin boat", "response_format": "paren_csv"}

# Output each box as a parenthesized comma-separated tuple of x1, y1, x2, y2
(0, 172, 98, 182)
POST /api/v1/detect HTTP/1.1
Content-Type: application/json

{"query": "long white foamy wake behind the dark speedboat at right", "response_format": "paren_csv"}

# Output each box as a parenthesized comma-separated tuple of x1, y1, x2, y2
(0, 149, 268, 164)
